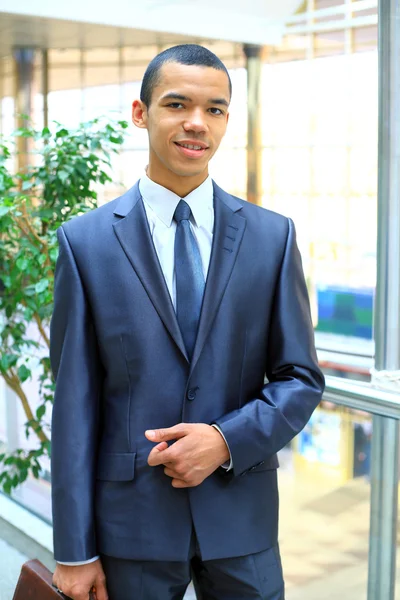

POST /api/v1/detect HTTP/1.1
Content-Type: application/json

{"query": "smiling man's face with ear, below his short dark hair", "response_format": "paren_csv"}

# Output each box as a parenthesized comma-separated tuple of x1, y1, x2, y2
(133, 63, 230, 180)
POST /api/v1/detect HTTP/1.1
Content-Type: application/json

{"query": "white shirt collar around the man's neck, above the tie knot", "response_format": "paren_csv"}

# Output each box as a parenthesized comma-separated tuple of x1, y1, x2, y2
(139, 175, 214, 229)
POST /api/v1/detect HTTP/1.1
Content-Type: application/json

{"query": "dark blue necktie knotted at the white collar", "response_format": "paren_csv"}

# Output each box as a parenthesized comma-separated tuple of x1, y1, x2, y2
(174, 200, 205, 359)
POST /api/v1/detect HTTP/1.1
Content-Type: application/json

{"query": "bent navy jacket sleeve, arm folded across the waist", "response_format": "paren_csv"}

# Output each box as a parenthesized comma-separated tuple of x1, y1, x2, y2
(215, 219, 325, 475)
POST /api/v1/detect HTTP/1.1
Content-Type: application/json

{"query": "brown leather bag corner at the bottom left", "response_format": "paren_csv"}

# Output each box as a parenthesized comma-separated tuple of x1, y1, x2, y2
(13, 559, 66, 600)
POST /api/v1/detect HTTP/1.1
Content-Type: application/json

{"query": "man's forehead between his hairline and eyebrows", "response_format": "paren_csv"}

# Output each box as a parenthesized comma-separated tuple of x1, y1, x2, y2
(153, 62, 230, 102)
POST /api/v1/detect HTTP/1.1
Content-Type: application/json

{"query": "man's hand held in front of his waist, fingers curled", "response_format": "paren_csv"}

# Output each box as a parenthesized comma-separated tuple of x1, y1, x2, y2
(145, 423, 230, 488)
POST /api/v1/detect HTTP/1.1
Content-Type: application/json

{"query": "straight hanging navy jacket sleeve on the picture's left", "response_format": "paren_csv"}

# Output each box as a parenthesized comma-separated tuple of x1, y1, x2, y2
(50, 227, 102, 562)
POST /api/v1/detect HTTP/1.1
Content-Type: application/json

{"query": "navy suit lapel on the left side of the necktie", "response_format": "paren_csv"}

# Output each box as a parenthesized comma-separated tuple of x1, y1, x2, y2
(113, 183, 188, 361)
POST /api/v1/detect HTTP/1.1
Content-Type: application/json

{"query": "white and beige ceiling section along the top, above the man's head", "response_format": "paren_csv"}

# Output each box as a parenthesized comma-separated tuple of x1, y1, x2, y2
(0, 0, 301, 56)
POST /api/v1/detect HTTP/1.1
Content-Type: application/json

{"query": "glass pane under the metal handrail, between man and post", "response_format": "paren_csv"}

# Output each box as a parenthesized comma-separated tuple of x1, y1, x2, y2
(278, 403, 372, 600)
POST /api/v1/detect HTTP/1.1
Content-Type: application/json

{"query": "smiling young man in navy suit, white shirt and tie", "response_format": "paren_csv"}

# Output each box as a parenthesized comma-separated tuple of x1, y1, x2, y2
(51, 45, 324, 600)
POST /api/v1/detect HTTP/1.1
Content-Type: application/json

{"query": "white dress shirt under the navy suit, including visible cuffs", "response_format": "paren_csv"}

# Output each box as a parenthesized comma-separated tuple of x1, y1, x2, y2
(58, 175, 232, 566)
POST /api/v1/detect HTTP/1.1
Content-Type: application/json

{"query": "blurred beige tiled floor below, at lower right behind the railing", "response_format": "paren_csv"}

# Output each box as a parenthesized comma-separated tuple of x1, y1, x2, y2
(280, 470, 400, 600)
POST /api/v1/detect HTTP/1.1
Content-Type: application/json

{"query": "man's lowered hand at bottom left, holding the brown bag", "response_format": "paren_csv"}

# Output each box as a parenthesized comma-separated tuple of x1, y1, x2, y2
(53, 559, 108, 600)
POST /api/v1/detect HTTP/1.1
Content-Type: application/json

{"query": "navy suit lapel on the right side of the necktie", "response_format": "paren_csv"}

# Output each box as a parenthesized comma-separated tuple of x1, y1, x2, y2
(190, 182, 246, 373)
